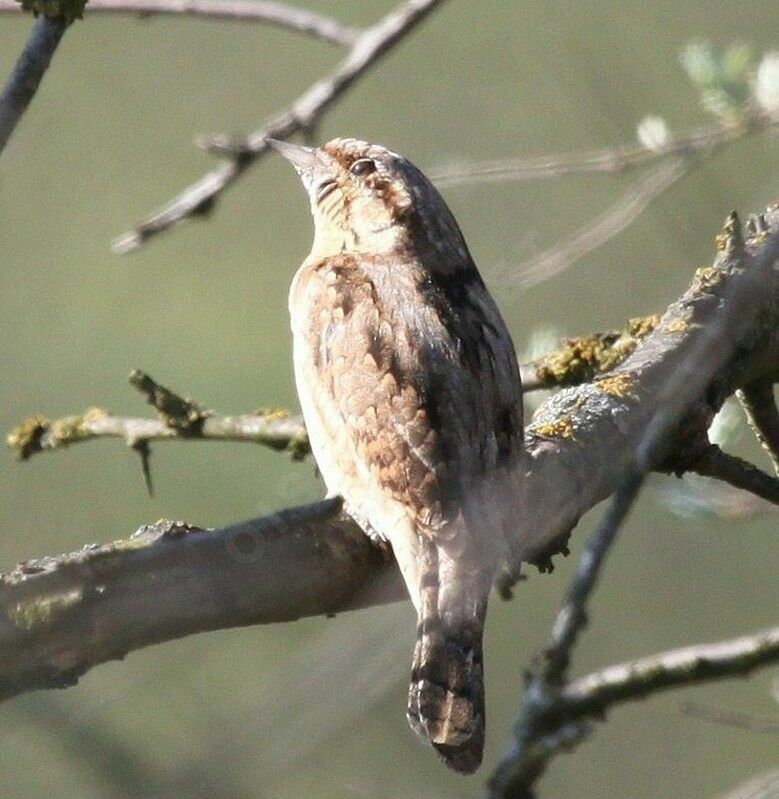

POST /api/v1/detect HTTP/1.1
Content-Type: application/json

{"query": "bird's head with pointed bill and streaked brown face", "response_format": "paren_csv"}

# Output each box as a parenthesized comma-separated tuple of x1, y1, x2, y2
(268, 134, 469, 260)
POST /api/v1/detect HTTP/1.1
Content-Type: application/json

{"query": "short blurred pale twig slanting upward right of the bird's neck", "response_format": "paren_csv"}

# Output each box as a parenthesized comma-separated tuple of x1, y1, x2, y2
(507, 157, 690, 288)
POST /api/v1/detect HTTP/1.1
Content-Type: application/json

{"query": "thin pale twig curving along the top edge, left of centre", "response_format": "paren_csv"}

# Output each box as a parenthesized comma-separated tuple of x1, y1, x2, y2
(0, 0, 358, 46)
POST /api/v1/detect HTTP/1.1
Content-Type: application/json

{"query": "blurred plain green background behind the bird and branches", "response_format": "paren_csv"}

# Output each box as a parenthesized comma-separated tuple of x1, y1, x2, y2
(0, 0, 779, 799)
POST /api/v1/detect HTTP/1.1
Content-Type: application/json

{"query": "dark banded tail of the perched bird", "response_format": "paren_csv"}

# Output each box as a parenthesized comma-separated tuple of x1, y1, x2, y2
(407, 547, 489, 774)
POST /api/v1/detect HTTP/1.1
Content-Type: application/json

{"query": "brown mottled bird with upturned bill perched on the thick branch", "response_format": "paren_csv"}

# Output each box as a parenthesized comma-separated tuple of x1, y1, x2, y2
(268, 138, 523, 774)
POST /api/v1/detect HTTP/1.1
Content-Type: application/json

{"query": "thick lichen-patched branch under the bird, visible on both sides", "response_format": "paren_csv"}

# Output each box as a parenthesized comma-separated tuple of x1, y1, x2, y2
(6, 208, 779, 708)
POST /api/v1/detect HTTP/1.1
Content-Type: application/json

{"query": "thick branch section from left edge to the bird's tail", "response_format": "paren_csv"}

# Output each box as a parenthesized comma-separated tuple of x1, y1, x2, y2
(0, 500, 403, 699)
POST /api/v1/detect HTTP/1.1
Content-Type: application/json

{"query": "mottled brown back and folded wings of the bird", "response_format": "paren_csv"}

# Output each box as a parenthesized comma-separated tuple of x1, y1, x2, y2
(291, 250, 522, 532)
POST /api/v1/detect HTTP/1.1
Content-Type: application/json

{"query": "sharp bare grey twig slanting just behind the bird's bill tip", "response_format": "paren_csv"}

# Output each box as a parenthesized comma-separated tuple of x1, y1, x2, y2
(114, 0, 444, 253)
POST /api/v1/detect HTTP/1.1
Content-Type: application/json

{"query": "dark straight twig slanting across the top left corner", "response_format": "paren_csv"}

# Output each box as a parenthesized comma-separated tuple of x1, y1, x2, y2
(0, 15, 68, 153)
